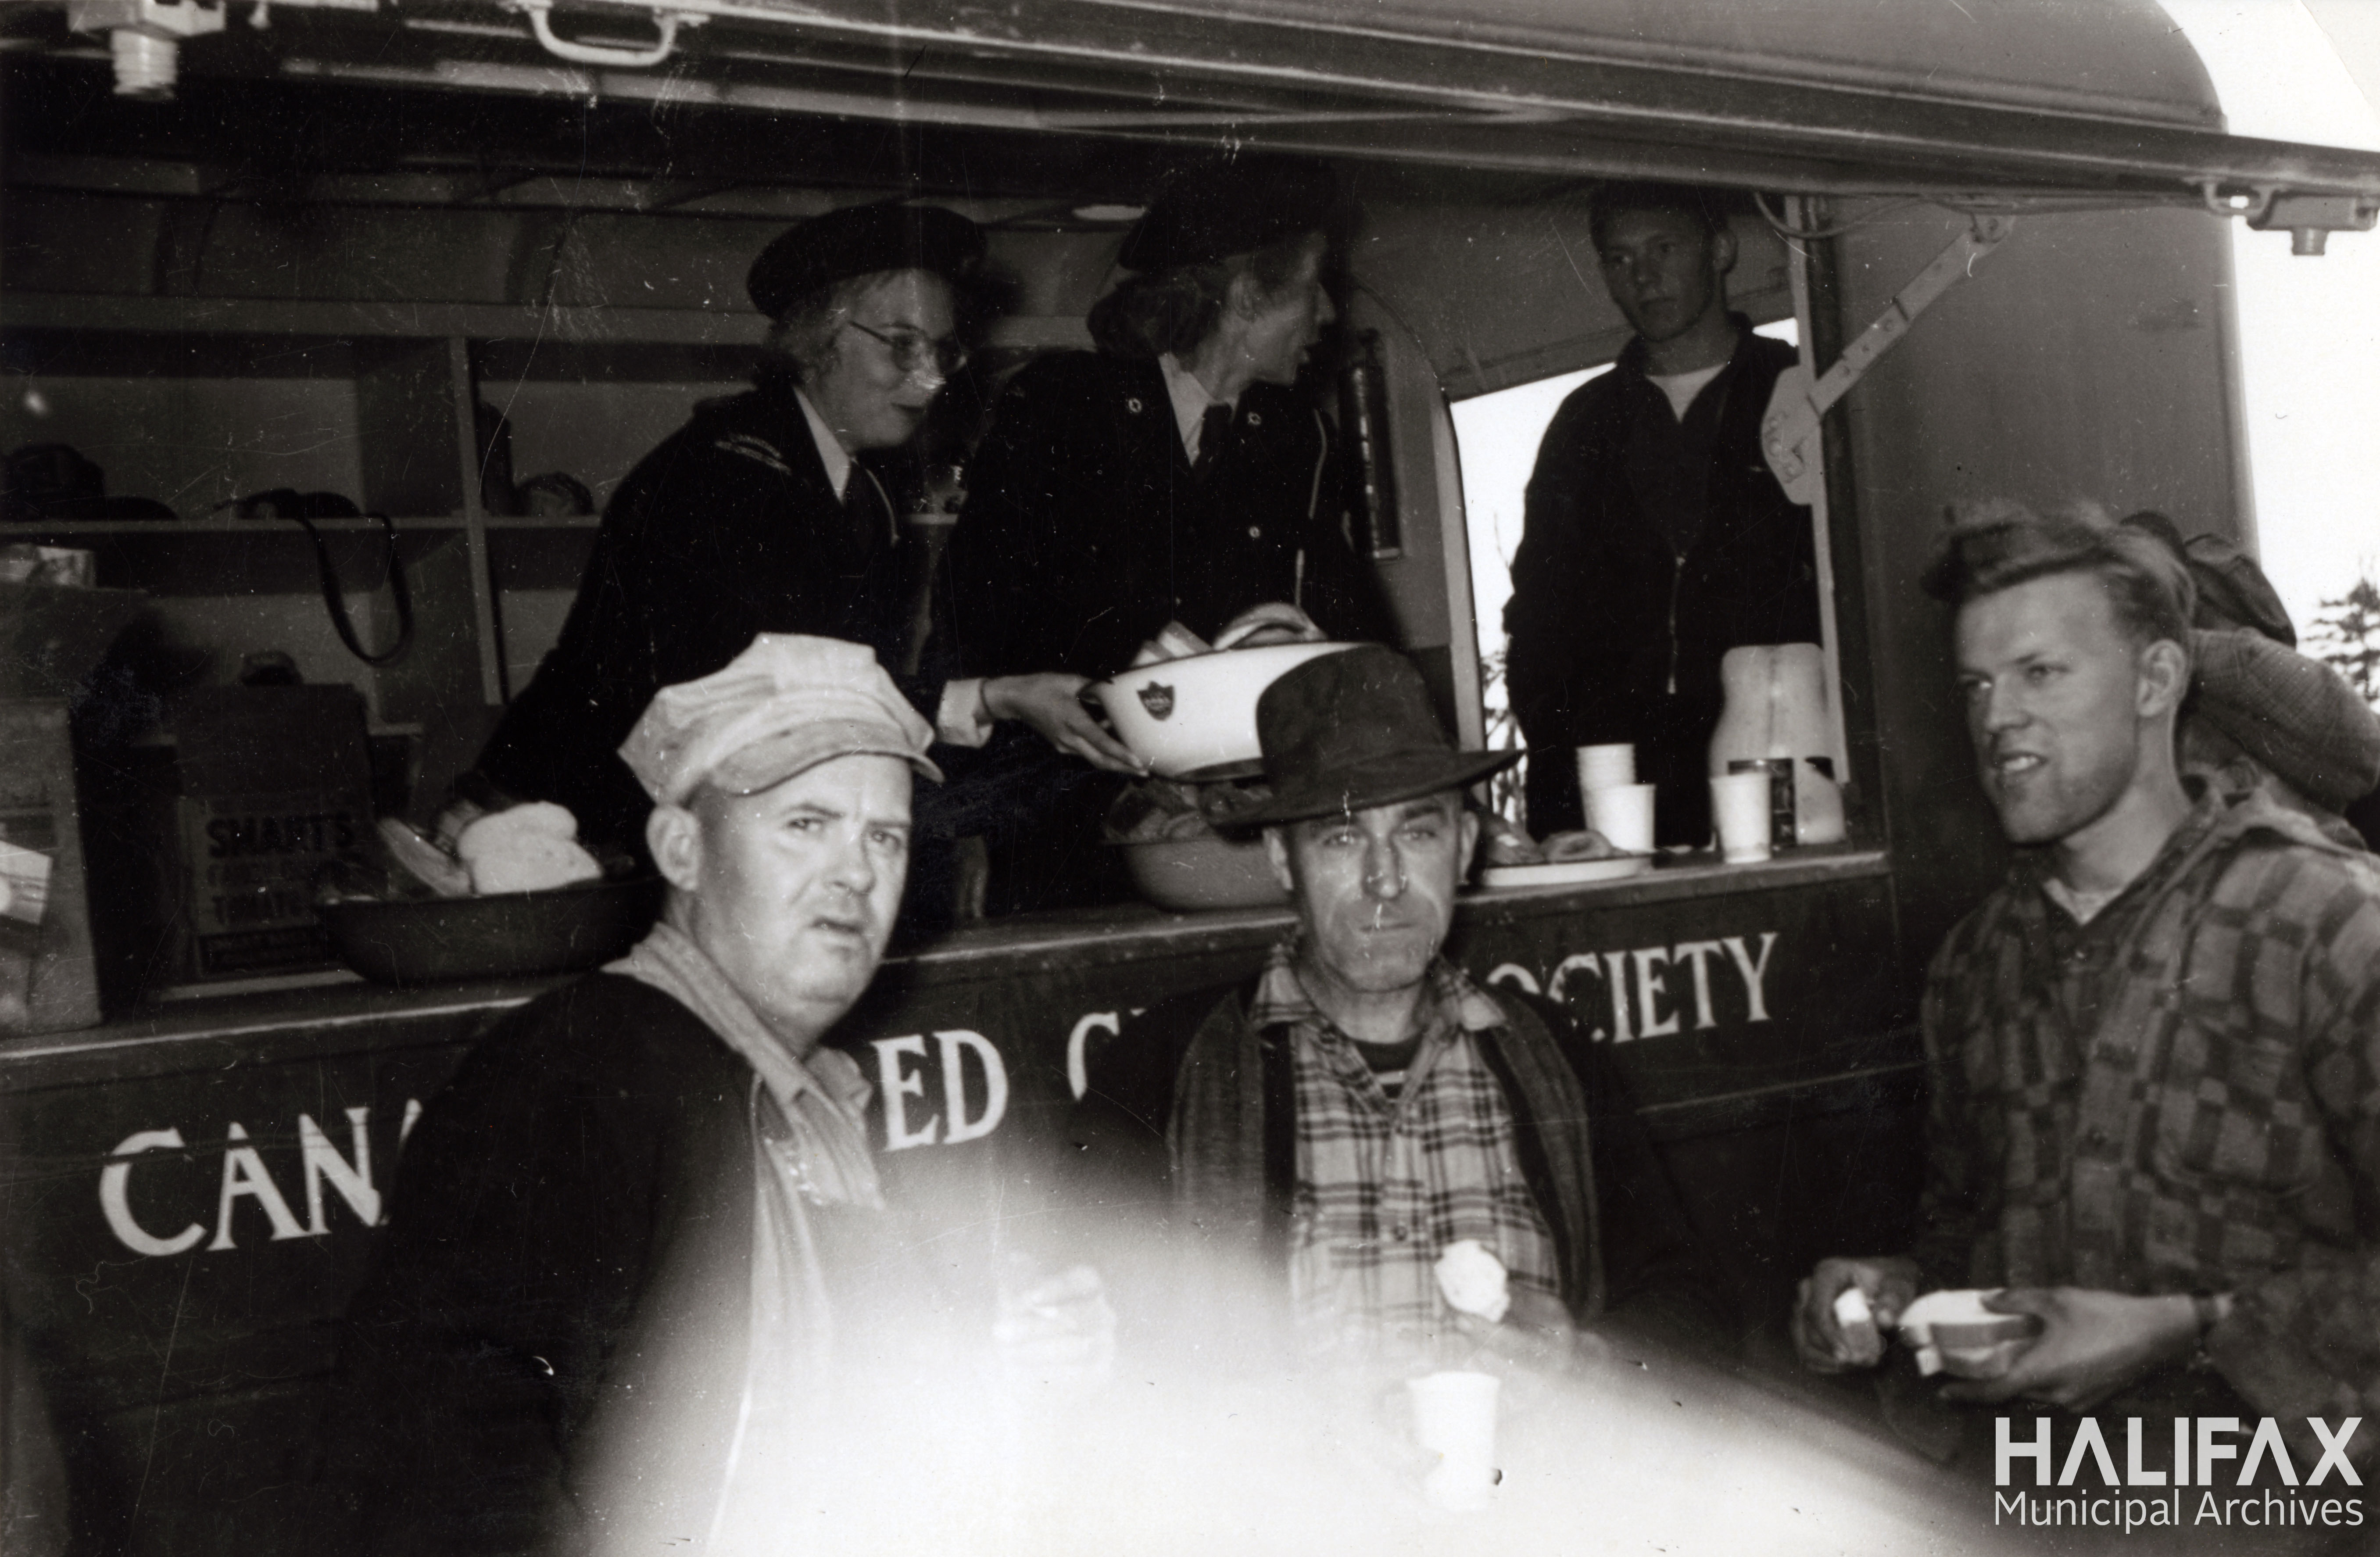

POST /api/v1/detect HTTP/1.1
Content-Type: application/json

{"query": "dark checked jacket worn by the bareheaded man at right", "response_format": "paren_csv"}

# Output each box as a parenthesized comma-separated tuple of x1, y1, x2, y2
(1916, 793, 2380, 1428)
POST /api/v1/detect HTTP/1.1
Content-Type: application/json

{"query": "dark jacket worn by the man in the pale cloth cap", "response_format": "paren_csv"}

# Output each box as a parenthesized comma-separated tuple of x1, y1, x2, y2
(321, 974, 757, 1557)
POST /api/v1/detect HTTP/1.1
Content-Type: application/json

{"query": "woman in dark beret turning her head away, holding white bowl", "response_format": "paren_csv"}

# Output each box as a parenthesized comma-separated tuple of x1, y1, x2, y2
(950, 157, 1395, 907)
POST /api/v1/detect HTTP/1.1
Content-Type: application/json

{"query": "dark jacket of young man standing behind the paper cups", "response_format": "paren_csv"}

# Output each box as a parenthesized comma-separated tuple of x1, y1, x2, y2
(1504, 317, 1818, 843)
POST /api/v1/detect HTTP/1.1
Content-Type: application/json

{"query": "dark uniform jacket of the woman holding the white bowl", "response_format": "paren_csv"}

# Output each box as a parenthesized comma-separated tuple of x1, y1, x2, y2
(950, 352, 1392, 676)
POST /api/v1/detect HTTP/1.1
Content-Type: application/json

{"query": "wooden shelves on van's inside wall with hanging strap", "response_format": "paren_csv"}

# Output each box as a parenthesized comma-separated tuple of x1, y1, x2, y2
(0, 293, 762, 729)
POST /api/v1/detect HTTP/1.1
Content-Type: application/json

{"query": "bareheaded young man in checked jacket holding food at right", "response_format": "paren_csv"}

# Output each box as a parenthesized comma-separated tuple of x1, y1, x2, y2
(1794, 505, 2380, 1464)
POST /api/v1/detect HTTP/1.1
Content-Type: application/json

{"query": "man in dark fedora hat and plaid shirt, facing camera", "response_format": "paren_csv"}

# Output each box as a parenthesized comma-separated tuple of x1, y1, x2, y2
(1069, 648, 1723, 1362)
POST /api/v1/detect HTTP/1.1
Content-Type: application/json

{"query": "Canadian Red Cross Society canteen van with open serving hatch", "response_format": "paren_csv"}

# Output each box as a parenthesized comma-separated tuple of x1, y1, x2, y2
(0, 0, 2380, 1552)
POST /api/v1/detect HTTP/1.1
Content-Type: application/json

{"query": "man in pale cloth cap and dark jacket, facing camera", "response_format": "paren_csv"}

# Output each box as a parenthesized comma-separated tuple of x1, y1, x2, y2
(331, 633, 1095, 1557)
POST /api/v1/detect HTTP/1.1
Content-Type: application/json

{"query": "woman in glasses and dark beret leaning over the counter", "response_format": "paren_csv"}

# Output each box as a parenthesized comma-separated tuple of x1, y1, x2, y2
(478, 205, 1128, 852)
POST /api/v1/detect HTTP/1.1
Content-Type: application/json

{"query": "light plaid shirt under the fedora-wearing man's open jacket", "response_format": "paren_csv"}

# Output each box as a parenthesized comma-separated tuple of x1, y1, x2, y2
(1249, 941, 1561, 1350)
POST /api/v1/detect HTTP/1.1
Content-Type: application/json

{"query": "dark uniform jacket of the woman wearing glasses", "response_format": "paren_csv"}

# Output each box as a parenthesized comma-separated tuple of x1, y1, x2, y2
(478, 381, 919, 852)
